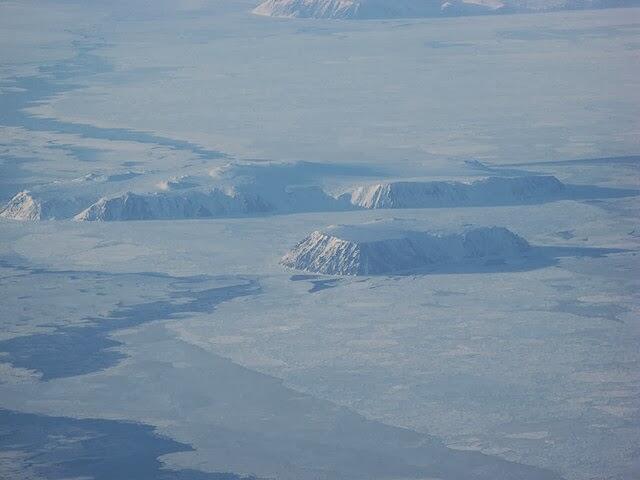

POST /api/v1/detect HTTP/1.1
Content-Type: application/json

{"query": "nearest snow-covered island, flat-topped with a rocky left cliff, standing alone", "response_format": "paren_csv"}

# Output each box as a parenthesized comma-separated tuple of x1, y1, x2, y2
(281, 219, 530, 275)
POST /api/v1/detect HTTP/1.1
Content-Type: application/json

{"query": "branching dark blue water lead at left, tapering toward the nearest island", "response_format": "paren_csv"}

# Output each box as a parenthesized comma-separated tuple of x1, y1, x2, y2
(0, 260, 260, 380)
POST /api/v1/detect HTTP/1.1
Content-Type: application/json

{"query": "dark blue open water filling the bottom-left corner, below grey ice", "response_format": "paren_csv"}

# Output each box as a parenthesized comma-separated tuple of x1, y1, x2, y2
(0, 409, 253, 480)
